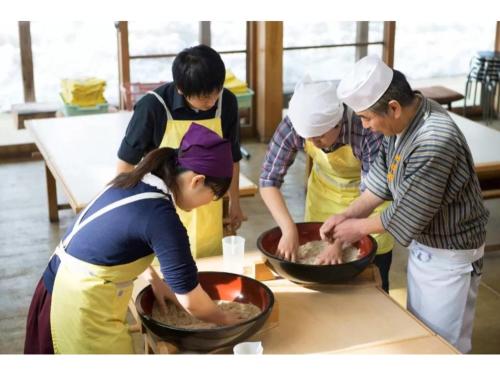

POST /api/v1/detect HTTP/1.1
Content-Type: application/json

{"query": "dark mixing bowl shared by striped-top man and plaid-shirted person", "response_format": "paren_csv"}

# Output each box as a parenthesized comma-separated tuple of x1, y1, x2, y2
(257, 222, 377, 284)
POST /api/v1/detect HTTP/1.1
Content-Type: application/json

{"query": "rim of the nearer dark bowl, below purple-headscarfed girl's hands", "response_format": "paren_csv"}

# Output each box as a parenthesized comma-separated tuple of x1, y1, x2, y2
(135, 271, 275, 333)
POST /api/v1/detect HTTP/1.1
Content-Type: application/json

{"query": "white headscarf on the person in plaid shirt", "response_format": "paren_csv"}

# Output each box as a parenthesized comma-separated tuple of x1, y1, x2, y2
(288, 76, 344, 138)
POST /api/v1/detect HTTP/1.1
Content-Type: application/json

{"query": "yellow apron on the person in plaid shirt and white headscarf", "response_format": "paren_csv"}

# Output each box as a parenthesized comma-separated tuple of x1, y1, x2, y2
(304, 111, 394, 254)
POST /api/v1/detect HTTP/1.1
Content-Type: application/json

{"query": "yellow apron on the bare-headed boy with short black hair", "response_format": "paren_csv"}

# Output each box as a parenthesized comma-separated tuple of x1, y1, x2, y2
(149, 91, 222, 262)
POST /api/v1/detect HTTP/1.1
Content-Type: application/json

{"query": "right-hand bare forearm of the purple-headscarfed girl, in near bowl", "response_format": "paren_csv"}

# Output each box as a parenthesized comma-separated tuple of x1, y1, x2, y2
(176, 284, 225, 324)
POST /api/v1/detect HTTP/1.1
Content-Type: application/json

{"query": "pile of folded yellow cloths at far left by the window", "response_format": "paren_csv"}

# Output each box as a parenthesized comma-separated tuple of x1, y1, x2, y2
(61, 78, 106, 107)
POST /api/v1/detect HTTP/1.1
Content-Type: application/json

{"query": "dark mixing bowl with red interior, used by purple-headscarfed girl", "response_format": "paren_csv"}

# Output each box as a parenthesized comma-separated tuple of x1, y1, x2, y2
(135, 272, 274, 352)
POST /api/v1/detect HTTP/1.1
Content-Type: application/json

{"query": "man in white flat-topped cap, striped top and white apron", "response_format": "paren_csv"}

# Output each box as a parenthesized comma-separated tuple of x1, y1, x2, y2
(320, 56, 489, 353)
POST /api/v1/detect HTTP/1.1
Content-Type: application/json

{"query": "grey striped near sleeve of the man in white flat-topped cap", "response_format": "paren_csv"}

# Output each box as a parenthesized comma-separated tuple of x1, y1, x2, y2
(381, 137, 457, 246)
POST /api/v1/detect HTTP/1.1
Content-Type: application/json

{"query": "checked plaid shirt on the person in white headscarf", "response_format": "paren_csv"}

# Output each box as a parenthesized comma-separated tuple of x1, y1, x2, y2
(259, 106, 383, 191)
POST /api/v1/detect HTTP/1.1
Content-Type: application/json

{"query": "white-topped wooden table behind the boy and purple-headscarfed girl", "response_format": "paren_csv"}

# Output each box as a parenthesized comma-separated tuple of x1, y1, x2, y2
(26, 112, 257, 222)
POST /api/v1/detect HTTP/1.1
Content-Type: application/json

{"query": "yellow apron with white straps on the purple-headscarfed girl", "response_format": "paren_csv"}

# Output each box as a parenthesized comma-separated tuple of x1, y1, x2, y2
(50, 189, 162, 354)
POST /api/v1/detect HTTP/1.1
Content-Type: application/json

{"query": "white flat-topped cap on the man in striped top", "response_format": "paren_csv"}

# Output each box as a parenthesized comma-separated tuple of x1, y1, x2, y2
(337, 55, 394, 112)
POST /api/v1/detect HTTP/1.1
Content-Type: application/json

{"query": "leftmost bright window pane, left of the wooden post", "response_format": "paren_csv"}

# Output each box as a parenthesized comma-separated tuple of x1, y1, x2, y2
(0, 20, 24, 111)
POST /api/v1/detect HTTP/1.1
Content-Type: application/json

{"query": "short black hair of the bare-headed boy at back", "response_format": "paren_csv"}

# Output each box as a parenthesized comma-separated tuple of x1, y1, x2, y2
(172, 44, 226, 96)
